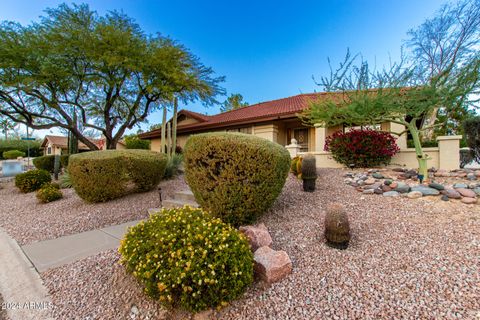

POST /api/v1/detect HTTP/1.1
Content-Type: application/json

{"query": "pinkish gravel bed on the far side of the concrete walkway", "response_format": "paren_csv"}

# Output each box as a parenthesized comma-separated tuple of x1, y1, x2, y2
(0, 177, 186, 245)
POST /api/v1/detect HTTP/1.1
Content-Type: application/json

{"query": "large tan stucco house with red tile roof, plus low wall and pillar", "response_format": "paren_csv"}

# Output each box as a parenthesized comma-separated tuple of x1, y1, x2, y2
(139, 92, 461, 169)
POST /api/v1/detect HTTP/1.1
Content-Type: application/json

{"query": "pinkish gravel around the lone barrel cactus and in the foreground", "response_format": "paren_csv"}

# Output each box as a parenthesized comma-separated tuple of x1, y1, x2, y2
(42, 169, 480, 320)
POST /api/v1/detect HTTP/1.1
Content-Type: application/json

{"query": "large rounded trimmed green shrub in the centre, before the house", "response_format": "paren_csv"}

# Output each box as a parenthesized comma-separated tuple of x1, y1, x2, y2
(184, 133, 290, 226)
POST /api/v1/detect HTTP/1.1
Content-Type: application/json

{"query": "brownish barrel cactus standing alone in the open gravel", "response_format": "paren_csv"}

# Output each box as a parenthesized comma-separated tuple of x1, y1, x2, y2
(325, 203, 350, 250)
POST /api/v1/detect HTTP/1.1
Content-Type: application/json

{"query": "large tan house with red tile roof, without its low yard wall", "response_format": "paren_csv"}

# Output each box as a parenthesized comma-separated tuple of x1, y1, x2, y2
(139, 93, 406, 152)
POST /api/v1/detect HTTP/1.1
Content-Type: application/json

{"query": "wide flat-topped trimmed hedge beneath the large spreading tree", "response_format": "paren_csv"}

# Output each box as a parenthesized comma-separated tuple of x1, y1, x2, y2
(68, 150, 167, 202)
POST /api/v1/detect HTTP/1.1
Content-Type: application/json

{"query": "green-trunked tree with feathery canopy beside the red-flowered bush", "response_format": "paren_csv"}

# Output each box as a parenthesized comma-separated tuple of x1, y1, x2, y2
(301, 52, 480, 178)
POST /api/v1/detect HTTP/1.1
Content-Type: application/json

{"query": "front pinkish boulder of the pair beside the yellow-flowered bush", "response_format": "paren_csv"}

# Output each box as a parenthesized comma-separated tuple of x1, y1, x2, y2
(254, 247, 292, 283)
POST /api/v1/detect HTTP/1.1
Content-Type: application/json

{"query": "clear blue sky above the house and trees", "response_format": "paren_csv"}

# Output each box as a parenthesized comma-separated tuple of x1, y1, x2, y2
(0, 0, 444, 135)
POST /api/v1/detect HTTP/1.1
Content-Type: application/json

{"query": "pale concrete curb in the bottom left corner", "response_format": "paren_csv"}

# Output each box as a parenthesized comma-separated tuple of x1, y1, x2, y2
(0, 228, 53, 320)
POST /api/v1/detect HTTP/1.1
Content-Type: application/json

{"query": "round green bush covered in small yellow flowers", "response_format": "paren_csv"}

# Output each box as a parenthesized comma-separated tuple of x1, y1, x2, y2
(119, 206, 253, 312)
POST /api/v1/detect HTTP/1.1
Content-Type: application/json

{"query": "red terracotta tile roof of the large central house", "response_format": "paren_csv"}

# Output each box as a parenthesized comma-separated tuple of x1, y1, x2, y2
(140, 92, 344, 139)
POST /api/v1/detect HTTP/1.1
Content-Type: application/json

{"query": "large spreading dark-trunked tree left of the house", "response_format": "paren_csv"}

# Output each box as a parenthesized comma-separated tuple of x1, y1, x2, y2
(0, 4, 223, 150)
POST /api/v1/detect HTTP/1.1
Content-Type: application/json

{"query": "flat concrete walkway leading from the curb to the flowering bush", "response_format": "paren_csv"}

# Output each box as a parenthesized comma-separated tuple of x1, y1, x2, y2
(22, 220, 141, 272)
